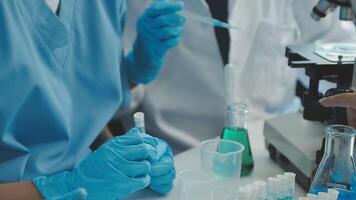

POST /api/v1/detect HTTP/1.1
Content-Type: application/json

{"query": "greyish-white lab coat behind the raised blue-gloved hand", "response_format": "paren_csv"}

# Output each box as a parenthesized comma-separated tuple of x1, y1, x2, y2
(125, 0, 225, 152)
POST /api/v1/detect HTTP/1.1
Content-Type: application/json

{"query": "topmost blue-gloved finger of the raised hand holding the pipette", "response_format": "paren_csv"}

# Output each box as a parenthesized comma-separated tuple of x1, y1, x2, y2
(144, 1, 184, 18)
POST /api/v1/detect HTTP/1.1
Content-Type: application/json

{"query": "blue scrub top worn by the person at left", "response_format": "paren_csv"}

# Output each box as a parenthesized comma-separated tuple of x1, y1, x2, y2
(0, 0, 129, 182)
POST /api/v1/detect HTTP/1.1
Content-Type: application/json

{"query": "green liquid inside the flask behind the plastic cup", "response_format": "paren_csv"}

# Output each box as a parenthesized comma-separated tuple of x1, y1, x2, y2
(221, 128, 253, 176)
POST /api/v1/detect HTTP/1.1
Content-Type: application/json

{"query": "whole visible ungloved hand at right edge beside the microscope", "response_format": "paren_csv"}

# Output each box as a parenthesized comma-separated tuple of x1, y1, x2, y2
(320, 93, 356, 128)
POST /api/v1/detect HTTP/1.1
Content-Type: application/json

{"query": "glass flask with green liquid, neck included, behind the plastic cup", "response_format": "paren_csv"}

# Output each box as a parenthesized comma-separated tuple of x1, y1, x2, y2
(221, 104, 253, 176)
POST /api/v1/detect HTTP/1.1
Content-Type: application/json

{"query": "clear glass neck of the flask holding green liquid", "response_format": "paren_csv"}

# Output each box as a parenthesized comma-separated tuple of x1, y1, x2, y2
(225, 104, 248, 129)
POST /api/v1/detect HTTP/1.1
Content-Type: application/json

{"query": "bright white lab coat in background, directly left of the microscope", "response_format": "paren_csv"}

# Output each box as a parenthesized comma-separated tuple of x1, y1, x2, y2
(230, 0, 355, 117)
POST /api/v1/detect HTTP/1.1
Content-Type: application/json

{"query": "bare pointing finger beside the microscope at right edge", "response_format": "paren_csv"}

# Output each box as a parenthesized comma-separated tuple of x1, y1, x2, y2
(319, 93, 356, 108)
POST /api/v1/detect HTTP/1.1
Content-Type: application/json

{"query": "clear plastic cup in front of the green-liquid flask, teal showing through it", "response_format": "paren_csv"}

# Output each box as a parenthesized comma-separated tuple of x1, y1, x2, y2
(201, 139, 244, 200)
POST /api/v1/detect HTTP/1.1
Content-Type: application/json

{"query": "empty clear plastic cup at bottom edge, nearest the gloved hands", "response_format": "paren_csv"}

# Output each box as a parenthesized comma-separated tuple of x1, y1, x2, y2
(178, 170, 214, 200)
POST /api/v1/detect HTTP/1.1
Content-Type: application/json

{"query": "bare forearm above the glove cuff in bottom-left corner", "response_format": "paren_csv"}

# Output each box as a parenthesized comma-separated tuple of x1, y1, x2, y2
(0, 182, 42, 200)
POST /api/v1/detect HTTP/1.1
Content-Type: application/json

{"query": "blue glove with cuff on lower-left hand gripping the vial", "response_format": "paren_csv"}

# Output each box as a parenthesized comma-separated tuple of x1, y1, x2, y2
(33, 129, 158, 200)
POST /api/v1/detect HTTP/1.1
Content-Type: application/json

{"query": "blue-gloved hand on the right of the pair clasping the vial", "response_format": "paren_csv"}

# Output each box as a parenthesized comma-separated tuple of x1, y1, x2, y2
(138, 133, 176, 195)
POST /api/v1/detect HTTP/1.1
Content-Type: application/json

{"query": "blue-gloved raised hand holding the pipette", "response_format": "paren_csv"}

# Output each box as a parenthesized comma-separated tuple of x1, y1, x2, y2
(128, 0, 185, 83)
